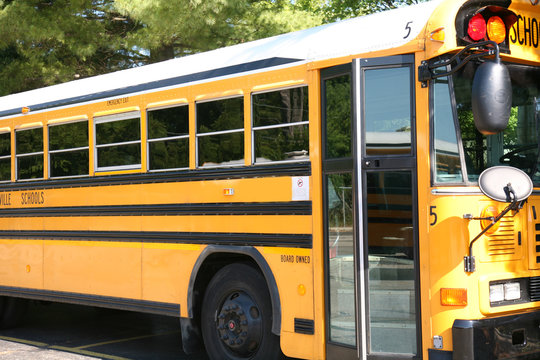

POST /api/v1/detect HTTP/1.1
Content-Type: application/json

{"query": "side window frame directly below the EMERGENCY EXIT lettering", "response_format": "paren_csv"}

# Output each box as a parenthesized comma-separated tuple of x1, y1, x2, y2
(93, 110, 142, 172)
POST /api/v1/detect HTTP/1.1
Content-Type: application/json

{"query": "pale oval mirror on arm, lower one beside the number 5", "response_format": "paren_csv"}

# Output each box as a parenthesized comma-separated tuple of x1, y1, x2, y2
(478, 166, 533, 203)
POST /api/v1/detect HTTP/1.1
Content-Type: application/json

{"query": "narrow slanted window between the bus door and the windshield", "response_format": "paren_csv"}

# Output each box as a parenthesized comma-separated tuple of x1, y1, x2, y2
(433, 79, 463, 183)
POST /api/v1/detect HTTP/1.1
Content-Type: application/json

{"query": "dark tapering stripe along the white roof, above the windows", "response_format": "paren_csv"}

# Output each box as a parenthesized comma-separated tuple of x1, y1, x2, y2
(0, 57, 302, 117)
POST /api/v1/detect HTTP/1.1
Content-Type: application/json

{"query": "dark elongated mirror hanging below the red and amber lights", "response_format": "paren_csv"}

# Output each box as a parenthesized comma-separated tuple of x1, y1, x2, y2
(472, 61, 512, 135)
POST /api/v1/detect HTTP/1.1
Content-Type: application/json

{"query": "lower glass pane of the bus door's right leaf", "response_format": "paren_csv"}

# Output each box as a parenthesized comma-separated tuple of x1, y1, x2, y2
(366, 171, 416, 354)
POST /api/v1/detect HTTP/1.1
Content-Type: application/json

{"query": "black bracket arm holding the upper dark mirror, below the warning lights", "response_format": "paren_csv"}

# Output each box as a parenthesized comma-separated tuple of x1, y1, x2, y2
(418, 41, 501, 87)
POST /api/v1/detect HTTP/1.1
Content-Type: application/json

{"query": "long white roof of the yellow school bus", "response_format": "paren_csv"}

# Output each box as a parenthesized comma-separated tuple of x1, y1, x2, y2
(0, 0, 443, 117)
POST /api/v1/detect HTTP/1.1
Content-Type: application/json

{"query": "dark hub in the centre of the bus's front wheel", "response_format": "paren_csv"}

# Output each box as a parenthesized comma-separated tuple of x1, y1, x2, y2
(216, 292, 262, 356)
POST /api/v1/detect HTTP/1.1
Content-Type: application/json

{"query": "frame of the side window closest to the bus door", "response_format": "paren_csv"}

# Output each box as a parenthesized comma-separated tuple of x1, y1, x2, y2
(250, 84, 311, 166)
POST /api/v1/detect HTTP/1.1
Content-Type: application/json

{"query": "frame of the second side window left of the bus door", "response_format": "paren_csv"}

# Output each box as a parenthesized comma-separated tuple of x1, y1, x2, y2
(194, 94, 246, 169)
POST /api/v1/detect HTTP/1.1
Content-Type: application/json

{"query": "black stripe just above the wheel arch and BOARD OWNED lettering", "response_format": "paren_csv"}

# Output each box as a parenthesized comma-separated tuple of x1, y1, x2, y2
(0, 230, 312, 249)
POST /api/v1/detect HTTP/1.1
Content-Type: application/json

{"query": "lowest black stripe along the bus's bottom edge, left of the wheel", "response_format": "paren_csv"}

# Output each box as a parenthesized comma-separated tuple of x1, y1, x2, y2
(0, 286, 180, 317)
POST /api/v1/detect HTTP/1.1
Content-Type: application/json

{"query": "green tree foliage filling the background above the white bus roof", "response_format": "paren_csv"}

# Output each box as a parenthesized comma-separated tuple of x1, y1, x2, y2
(0, 0, 423, 95)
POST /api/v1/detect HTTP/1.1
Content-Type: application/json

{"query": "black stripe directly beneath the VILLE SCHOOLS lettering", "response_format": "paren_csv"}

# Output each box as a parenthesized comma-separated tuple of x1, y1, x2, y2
(0, 201, 311, 217)
